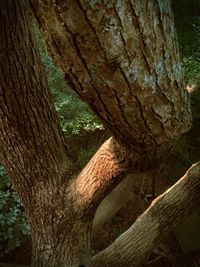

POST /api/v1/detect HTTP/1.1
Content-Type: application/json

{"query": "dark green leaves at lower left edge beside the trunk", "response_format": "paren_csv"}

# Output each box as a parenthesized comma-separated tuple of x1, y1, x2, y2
(0, 166, 30, 256)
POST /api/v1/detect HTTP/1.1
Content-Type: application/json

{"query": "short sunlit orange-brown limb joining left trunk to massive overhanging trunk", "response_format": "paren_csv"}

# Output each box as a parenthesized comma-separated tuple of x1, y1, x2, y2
(72, 137, 130, 211)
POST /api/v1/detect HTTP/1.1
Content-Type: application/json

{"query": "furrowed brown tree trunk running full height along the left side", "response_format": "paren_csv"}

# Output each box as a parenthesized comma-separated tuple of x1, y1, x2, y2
(0, 0, 91, 267)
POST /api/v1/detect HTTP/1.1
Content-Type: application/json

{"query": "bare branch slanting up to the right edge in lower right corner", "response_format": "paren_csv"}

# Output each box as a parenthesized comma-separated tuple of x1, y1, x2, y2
(94, 162, 200, 267)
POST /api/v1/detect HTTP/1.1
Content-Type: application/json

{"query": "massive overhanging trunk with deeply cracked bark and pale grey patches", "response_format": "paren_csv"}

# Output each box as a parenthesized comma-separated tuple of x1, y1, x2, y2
(31, 0, 190, 170)
